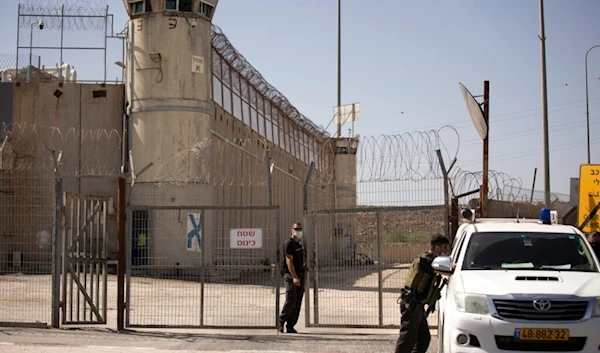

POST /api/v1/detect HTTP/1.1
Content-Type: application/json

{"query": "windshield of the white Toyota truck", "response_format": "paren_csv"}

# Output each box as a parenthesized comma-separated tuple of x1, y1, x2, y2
(462, 232, 598, 272)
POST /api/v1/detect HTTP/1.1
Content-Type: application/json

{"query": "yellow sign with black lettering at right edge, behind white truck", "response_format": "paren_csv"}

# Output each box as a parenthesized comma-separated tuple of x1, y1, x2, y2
(577, 164, 600, 233)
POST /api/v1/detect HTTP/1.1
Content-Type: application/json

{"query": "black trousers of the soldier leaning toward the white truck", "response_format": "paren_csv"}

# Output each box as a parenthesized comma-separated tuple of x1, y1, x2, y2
(396, 299, 431, 353)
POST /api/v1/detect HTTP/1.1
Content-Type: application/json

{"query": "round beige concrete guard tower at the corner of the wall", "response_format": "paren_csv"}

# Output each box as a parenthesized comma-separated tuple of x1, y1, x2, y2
(124, 0, 218, 266)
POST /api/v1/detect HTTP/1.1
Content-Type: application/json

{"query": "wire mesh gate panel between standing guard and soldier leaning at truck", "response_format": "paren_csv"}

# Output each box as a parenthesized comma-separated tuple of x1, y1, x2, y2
(304, 206, 444, 328)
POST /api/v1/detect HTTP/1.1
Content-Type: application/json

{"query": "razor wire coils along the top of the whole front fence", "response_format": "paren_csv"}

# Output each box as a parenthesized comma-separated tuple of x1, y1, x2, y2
(0, 119, 566, 202)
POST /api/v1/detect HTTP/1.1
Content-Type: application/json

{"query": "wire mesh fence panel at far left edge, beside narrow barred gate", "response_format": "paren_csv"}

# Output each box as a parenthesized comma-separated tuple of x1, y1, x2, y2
(0, 170, 54, 324)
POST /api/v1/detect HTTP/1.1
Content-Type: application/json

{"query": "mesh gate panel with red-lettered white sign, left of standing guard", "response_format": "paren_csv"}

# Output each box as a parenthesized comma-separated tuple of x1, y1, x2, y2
(126, 206, 279, 328)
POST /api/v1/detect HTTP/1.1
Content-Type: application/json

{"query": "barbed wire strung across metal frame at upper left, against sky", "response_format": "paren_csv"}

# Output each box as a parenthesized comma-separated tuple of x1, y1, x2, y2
(19, 0, 108, 31)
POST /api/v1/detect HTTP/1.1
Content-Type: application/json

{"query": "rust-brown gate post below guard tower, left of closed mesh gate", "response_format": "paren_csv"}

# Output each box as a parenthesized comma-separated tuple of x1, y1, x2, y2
(117, 177, 127, 331)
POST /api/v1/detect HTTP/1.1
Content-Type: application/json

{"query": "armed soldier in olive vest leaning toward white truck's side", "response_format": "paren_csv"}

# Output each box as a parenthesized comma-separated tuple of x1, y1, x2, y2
(396, 234, 450, 353)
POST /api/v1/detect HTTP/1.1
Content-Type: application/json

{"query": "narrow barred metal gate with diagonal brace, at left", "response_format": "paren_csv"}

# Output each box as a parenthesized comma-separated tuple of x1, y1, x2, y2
(61, 193, 110, 324)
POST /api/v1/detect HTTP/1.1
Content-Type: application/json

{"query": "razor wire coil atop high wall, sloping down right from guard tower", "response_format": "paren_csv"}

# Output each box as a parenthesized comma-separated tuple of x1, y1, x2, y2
(212, 25, 329, 138)
